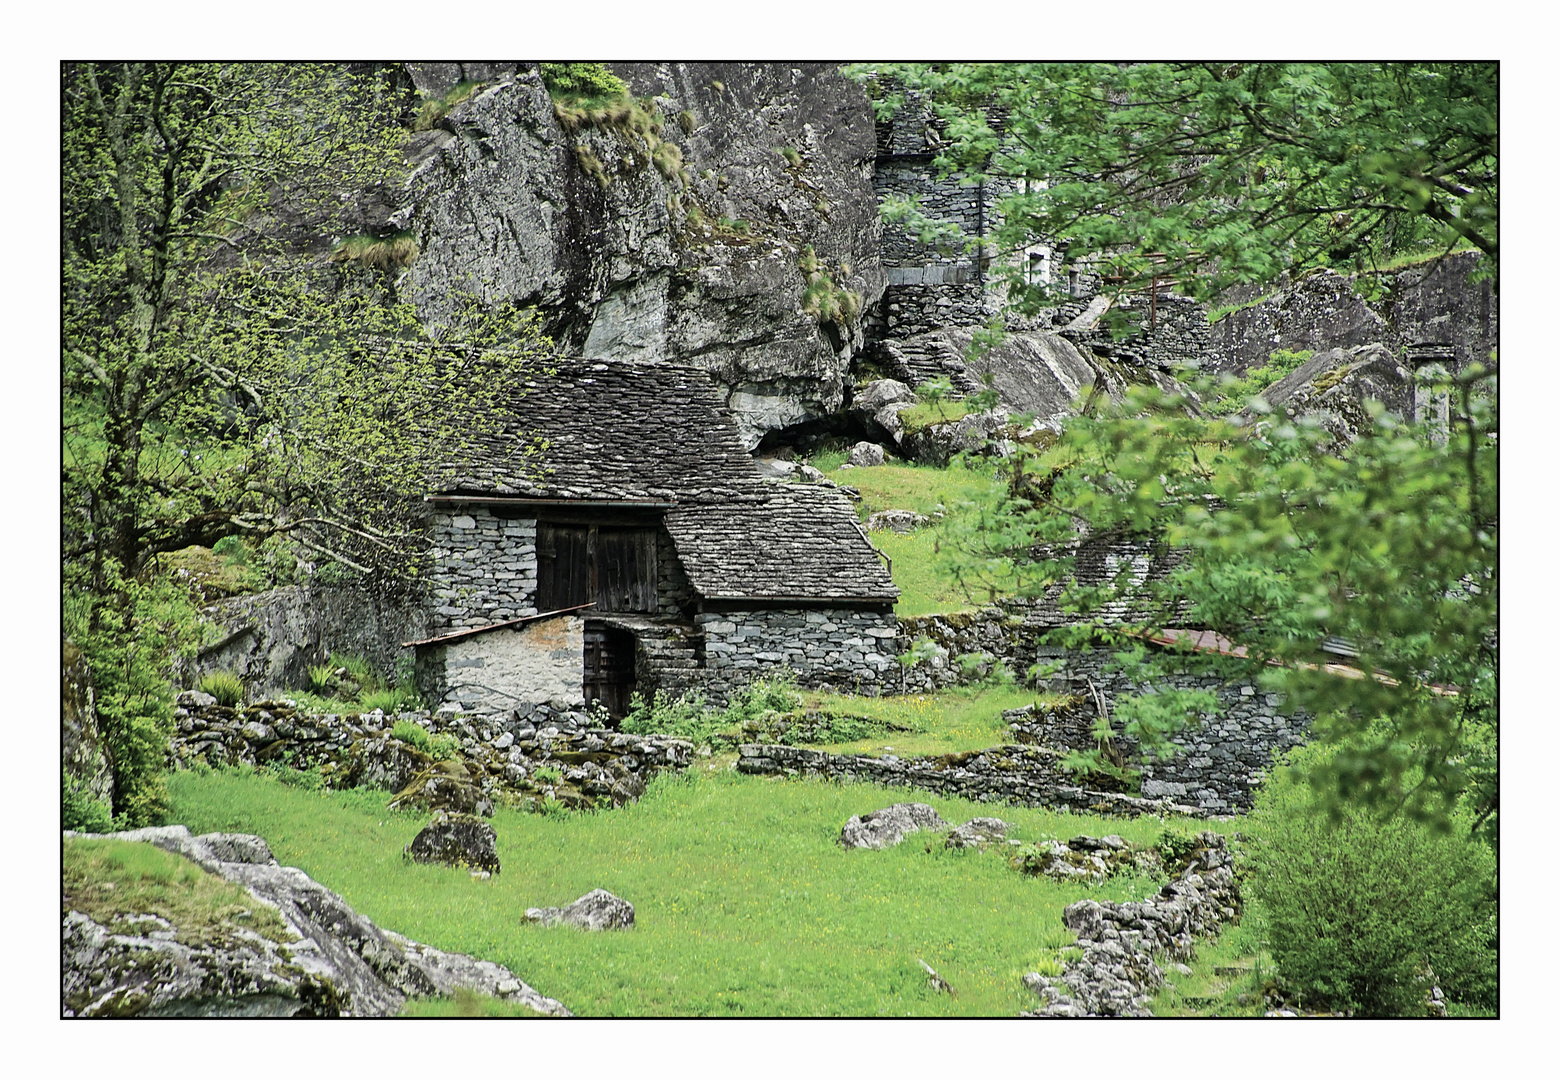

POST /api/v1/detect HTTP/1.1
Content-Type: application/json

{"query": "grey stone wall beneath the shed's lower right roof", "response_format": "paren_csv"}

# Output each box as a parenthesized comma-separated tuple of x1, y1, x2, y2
(694, 607, 899, 704)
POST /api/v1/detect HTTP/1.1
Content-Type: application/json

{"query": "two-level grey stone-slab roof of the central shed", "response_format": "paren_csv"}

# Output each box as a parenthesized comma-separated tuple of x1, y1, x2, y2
(438, 359, 899, 601)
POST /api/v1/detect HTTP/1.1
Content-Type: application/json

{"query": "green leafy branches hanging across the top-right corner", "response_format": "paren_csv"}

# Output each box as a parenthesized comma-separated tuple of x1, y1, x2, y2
(856, 62, 1499, 309)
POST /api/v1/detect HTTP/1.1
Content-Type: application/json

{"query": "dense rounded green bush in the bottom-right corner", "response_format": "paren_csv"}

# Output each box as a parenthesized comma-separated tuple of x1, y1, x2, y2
(1248, 748, 1496, 1016)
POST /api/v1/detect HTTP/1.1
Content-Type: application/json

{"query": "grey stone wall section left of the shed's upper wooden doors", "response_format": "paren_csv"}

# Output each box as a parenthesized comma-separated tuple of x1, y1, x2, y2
(431, 506, 537, 632)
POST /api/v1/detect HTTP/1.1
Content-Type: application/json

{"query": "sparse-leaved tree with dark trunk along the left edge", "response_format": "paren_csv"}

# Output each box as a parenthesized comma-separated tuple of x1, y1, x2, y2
(62, 62, 546, 819)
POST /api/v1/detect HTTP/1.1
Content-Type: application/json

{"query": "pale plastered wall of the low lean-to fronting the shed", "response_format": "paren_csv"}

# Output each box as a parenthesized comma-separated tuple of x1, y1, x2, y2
(417, 615, 585, 716)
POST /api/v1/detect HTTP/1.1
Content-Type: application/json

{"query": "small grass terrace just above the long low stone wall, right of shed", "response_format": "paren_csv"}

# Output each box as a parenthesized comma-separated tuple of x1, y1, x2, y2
(802, 687, 1051, 757)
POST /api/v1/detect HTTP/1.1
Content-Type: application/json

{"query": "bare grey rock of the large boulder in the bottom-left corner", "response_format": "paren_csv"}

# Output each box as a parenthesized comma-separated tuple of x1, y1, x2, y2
(61, 826, 573, 1016)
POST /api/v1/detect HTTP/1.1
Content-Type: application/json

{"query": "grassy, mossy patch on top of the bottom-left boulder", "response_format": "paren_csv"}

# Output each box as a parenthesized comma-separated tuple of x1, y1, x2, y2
(62, 838, 295, 944)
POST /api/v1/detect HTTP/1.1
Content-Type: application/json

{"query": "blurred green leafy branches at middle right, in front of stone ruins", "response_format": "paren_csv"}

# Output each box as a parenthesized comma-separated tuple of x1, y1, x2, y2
(944, 365, 1499, 835)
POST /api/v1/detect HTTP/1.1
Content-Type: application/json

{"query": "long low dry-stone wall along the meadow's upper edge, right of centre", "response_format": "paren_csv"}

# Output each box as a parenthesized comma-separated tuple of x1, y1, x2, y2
(736, 744, 1200, 815)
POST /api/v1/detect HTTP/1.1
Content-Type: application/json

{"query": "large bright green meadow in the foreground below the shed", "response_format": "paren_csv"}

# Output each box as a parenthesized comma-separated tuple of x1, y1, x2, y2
(170, 771, 1216, 1016)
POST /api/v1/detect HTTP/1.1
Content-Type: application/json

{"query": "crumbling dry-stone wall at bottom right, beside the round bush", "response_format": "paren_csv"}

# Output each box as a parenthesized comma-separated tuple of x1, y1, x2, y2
(1023, 832, 1240, 1018)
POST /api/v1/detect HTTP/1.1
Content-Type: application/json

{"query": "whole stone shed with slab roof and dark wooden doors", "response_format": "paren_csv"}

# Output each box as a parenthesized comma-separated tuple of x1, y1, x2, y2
(410, 359, 899, 721)
